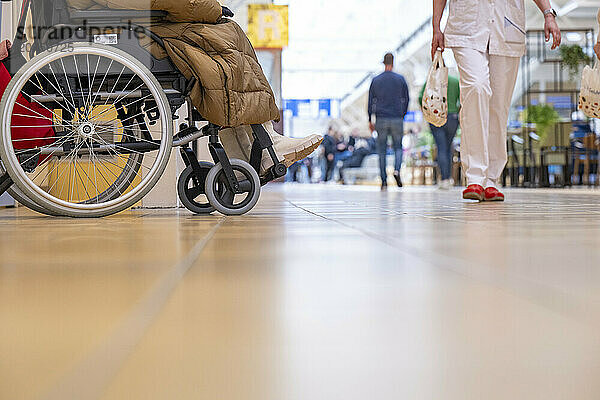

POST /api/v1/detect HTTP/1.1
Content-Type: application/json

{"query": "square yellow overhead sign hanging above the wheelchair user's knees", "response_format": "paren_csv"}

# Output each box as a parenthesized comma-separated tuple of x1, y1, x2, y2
(248, 4, 289, 49)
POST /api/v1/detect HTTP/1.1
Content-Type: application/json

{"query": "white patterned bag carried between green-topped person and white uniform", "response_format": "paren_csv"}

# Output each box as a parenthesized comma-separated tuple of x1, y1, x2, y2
(421, 50, 448, 127)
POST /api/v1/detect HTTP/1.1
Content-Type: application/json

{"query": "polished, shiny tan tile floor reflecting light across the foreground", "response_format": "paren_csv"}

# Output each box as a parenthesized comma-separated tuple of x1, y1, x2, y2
(0, 185, 600, 400)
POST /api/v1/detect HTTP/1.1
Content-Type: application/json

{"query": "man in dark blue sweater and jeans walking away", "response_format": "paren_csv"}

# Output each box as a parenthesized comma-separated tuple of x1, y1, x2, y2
(368, 53, 410, 190)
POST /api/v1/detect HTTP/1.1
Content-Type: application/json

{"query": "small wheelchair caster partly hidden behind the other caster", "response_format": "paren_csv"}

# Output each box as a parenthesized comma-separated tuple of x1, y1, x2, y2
(177, 162, 215, 215)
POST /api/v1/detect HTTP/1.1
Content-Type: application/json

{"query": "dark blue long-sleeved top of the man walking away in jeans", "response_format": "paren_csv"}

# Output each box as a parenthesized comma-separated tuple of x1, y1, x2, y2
(369, 71, 410, 121)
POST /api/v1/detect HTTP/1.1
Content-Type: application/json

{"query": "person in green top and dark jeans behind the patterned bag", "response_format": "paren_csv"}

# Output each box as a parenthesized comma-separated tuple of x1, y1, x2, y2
(419, 76, 460, 190)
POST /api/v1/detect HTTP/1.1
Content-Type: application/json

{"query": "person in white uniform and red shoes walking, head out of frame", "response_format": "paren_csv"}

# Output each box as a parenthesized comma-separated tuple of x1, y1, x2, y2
(431, 0, 561, 201)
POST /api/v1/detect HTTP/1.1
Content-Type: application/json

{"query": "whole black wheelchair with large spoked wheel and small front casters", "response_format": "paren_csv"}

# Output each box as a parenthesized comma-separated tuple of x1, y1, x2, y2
(0, 0, 287, 217)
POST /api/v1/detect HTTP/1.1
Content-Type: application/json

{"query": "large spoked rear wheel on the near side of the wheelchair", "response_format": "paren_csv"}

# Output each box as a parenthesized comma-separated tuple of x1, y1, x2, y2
(0, 43, 173, 217)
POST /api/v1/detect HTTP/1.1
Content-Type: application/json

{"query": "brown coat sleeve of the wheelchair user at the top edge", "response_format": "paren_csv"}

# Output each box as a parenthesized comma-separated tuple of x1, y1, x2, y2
(67, 0, 223, 23)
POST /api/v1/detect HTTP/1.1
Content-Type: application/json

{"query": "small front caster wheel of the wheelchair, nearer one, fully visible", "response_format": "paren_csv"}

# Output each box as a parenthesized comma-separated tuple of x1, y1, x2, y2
(205, 159, 260, 215)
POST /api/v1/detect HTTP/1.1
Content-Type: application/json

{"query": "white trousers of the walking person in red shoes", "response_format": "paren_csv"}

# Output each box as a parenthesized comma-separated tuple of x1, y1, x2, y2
(452, 47, 520, 187)
